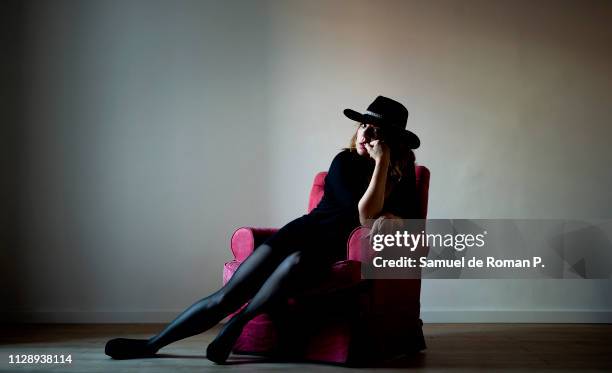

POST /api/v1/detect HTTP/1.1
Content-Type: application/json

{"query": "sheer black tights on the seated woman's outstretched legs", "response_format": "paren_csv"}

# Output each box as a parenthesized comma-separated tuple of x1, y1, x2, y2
(148, 244, 308, 351)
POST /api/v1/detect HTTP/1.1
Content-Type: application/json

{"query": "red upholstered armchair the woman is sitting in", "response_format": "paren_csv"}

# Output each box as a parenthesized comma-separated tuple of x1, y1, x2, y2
(223, 165, 429, 365)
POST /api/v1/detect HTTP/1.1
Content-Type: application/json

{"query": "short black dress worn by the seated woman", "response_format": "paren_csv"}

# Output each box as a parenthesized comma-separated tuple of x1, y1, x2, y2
(264, 150, 415, 266)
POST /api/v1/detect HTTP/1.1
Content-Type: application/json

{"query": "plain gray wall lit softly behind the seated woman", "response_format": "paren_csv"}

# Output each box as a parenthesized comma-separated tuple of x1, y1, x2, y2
(3, 0, 612, 322)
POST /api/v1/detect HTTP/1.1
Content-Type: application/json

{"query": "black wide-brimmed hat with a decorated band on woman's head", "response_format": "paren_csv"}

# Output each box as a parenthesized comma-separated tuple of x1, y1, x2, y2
(344, 96, 421, 149)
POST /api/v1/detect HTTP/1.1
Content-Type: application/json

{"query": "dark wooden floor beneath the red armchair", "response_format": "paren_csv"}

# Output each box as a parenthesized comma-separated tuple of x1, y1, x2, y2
(0, 324, 612, 372)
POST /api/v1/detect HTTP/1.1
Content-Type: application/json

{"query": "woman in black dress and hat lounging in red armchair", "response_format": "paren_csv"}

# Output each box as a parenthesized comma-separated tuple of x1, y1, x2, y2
(105, 96, 420, 363)
